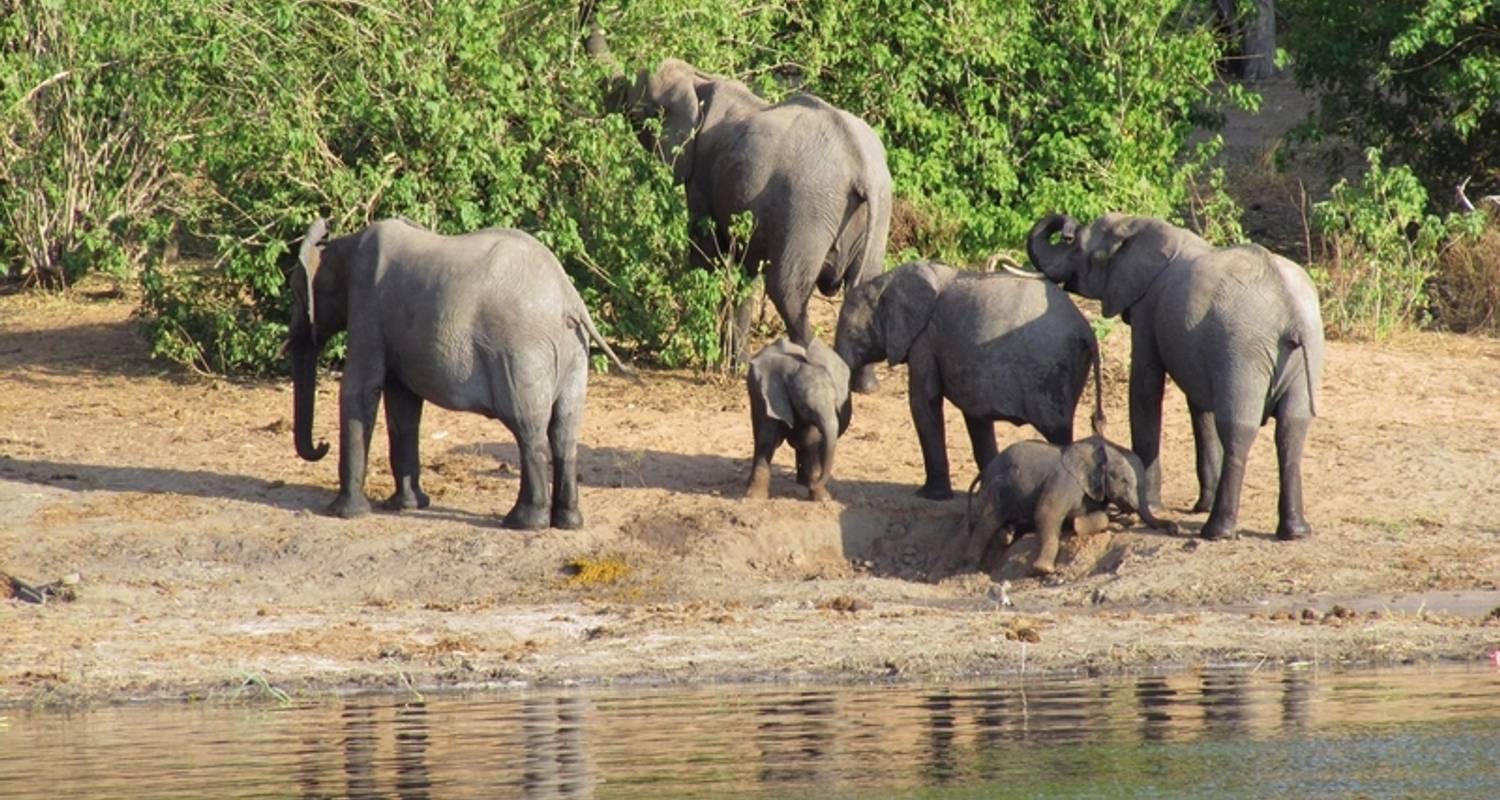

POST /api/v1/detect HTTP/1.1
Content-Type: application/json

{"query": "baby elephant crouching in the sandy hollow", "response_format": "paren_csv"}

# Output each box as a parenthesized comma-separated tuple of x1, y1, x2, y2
(969, 435, 1178, 575)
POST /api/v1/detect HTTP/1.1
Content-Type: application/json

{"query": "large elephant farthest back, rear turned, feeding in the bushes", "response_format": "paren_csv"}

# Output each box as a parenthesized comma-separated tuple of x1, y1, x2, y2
(608, 59, 891, 392)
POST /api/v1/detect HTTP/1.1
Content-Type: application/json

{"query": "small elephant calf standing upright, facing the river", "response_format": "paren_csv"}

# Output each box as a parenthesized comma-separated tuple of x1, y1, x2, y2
(746, 338, 851, 500)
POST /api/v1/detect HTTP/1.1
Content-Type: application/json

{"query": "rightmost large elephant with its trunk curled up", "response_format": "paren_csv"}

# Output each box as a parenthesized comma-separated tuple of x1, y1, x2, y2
(1028, 215, 1323, 539)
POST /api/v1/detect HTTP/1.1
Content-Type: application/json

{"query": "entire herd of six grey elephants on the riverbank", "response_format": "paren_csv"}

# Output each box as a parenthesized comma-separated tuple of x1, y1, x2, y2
(288, 60, 1323, 573)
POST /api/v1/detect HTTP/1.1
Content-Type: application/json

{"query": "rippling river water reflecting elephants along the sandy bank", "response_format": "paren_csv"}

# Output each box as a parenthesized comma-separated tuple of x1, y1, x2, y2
(0, 666, 1500, 800)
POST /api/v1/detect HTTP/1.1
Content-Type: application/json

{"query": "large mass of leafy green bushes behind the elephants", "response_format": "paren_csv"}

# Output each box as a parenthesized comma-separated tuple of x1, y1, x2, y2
(0, 0, 1233, 372)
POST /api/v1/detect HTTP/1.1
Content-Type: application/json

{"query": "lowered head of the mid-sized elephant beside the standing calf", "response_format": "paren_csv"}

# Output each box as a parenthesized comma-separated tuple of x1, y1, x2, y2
(834, 261, 957, 376)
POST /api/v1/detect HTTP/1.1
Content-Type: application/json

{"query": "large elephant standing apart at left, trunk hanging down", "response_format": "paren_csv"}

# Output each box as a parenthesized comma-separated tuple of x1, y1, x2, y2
(288, 219, 630, 530)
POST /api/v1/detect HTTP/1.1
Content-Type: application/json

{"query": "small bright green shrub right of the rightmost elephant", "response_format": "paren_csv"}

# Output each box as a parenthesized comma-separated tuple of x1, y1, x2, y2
(1311, 149, 1482, 339)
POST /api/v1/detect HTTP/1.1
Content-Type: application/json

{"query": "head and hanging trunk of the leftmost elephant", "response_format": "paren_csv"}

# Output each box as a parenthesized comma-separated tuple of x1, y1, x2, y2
(288, 219, 348, 461)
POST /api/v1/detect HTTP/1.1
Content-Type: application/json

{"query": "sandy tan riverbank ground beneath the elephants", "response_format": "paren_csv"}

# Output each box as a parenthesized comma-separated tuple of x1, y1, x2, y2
(0, 285, 1500, 702)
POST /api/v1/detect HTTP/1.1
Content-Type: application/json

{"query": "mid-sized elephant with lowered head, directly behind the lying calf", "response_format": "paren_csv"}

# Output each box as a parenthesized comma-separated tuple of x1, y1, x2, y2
(834, 261, 1098, 500)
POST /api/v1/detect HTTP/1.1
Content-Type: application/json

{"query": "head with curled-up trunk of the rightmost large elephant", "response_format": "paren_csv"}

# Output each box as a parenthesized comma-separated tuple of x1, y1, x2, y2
(1026, 213, 1209, 317)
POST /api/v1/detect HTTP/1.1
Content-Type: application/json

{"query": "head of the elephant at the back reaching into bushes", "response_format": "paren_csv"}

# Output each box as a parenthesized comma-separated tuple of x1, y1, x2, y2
(605, 59, 711, 183)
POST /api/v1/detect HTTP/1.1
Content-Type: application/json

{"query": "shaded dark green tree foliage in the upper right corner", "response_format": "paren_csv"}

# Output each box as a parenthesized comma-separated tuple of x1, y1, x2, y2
(1280, 0, 1500, 198)
